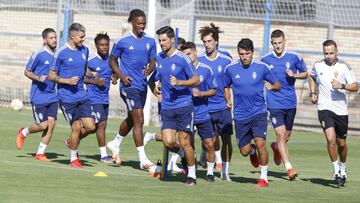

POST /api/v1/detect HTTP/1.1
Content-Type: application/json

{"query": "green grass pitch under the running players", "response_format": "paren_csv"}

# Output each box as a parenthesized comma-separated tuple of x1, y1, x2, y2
(0, 109, 360, 202)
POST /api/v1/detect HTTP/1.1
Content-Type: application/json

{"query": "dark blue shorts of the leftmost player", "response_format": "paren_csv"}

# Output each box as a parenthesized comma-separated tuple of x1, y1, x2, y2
(32, 102, 58, 124)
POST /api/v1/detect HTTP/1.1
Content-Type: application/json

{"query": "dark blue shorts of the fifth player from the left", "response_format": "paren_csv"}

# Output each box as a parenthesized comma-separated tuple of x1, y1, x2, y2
(160, 105, 194, 133)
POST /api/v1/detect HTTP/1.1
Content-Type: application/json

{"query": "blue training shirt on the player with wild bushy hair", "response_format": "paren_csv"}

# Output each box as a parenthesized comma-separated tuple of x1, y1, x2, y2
(198, 52, 232, 113)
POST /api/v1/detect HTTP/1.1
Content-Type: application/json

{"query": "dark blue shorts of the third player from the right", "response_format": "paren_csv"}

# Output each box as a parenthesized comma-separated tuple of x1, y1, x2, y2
(235, 113, 267, 148)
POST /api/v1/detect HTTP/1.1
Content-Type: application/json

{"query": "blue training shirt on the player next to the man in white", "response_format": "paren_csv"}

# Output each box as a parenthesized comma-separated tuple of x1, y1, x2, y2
(261, 51, 307, 109)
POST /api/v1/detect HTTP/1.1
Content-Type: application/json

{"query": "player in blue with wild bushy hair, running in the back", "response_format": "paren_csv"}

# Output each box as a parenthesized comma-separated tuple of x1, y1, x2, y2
(199, 23, 233, 181)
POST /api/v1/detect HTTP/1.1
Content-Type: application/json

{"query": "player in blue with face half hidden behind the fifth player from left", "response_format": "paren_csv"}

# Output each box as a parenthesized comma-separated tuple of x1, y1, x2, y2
(181, 42, 217, 182)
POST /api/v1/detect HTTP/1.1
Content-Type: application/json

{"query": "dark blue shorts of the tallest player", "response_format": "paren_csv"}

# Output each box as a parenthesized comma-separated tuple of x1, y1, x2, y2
(120, 88, 147, 111)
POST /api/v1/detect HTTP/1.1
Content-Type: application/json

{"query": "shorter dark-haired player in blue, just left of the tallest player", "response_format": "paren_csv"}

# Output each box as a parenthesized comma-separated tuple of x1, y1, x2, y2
(84, 33, 116, 163)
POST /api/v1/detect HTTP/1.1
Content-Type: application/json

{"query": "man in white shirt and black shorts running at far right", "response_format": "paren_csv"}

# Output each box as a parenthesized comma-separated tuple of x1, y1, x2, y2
(309, 40, 359, 186)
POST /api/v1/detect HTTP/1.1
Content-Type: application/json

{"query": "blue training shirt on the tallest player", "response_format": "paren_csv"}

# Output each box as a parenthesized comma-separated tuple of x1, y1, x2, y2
(111, 32, 157, 91)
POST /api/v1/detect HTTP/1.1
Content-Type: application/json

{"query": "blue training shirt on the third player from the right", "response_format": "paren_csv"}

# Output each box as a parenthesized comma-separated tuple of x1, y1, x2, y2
(224, 60, 276, 121)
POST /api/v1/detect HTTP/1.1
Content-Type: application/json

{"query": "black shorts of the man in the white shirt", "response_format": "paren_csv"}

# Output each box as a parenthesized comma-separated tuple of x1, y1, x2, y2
(318, 110, 349, 139)
